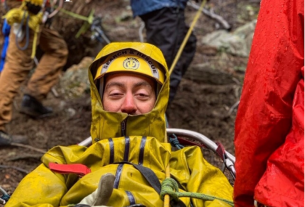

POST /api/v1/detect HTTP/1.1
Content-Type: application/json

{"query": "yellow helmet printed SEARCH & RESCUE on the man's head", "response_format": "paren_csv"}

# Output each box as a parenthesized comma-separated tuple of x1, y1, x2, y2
(94, 49, 165, 85)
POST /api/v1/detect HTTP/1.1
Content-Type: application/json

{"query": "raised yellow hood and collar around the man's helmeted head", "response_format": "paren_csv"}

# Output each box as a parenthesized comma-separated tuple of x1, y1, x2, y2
(89, 42, 169, 143)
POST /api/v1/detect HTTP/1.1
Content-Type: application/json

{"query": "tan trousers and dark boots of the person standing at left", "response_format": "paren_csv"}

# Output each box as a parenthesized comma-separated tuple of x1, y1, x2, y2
(0, 0, 68, 147)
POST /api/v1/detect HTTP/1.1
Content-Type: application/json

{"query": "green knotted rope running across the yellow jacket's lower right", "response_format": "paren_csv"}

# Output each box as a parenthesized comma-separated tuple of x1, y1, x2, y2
(160, 178, 234, 206)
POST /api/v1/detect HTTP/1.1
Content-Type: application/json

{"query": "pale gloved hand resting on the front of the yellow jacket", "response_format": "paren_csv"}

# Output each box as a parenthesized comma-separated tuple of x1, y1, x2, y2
(75, 173, 115, 207)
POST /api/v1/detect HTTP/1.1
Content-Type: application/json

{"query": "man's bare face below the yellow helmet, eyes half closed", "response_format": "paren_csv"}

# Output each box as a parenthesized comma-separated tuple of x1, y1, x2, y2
(103, 73, 156, 115)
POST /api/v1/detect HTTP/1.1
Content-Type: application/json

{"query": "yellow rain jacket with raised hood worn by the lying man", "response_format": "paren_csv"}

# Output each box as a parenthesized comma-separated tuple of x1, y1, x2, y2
(6, 43, 233, 207)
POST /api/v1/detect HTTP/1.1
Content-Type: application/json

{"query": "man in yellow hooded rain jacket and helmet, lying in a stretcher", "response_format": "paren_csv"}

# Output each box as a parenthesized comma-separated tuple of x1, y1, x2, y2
(6, 42, 233, 207)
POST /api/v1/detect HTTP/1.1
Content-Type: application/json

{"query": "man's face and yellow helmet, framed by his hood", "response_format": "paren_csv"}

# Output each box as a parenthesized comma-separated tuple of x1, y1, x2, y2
(95, 49, 164, 115)
